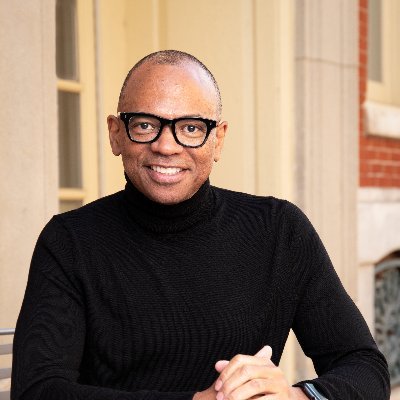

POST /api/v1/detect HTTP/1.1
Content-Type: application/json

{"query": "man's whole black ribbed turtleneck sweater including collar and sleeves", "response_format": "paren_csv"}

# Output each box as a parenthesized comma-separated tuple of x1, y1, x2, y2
(12, 181, 389, 400)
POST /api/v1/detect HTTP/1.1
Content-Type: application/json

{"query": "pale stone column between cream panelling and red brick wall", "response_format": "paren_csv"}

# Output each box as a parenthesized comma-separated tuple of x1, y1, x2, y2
(295, 0, 358, 378)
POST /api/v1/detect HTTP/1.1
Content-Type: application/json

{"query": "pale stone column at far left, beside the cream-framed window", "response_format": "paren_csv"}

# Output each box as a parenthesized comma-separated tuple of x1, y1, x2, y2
(0, 0, 58, 328)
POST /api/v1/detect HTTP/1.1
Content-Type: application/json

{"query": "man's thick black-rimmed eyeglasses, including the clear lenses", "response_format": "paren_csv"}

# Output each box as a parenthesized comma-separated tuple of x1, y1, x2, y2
(118, 112, 217, 148)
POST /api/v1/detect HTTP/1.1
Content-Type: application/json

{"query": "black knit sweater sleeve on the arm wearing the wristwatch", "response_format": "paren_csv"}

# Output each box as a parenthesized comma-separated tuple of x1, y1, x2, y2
(284, 206, 390, 400)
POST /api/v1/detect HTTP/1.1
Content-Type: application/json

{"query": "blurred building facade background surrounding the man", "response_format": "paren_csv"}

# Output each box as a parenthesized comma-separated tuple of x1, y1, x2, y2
(0, 0, 400, 399)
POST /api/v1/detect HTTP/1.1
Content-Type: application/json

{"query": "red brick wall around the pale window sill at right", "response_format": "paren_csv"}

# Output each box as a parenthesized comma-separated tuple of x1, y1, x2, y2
(359, 0, 400, 188)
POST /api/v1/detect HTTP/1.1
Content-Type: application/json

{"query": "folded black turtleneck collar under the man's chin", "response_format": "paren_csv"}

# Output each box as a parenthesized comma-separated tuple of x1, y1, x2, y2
(124, 174, 214, 233)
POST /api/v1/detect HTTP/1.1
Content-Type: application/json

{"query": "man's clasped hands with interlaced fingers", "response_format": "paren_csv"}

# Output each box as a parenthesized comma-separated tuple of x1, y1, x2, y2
(194, 346, 308, 400)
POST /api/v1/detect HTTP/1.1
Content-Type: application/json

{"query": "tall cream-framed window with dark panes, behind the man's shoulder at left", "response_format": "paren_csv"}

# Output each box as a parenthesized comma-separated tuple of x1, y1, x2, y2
(56, 0, 98, 212)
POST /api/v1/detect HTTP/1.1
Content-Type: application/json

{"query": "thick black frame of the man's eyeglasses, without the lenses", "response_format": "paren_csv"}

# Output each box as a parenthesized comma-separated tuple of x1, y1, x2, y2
(118, 112, 218, 149)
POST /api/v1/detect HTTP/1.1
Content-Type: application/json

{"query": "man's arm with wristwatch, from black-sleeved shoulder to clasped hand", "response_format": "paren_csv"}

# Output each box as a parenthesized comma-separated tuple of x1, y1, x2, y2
(202, 204, 390, 400)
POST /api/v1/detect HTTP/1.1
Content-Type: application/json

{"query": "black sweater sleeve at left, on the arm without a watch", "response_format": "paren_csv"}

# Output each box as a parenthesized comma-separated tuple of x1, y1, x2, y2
(11, 218, 194, 400)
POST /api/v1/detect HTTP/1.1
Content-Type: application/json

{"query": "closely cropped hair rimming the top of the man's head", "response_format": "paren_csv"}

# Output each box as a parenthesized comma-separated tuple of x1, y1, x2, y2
(118, 50, 222, 119)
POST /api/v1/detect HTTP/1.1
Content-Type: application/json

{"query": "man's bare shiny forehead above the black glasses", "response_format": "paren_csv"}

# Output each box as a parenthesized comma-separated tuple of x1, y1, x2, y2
(121, 64, 218, 118)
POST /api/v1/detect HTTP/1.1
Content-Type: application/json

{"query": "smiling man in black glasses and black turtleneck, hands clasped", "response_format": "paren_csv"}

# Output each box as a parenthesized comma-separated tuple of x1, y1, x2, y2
(12, 51, 389, 400)
